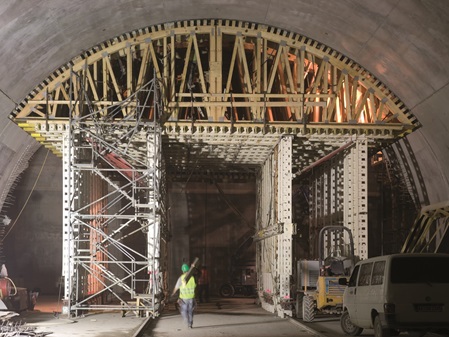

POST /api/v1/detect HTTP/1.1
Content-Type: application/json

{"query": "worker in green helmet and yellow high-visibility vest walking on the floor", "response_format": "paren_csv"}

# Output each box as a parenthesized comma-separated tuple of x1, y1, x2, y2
(172, 263, 196, 329)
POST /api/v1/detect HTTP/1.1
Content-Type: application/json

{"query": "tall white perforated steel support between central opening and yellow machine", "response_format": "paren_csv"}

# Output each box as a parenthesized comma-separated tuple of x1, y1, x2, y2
(254, 137, 295, 317)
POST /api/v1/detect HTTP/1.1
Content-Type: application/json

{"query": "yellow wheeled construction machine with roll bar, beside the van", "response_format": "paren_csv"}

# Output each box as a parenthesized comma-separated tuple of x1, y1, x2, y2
(296, 226, 355, 322)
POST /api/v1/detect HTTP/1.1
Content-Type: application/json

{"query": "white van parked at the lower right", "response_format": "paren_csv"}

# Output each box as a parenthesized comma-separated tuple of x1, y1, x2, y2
(339, 253, 449, 337)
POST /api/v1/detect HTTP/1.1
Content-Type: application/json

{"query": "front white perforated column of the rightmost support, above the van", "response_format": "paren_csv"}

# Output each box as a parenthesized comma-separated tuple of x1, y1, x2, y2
(344, 138, 368, 259)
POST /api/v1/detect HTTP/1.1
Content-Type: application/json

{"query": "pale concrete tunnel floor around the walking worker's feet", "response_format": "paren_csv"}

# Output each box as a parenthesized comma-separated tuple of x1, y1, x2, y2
(14, 296, 320, 337)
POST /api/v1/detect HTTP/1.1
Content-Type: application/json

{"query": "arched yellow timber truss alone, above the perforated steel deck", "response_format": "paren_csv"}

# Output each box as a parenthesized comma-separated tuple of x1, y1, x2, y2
(11, 20, 419, 150)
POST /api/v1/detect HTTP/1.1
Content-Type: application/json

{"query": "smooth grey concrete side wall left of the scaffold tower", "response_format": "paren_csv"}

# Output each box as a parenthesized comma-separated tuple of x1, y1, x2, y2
(4, 147, 64, 294)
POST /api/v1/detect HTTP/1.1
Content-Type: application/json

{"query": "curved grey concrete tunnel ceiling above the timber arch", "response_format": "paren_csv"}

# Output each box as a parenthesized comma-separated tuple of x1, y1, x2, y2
(0, 0, 449, 201)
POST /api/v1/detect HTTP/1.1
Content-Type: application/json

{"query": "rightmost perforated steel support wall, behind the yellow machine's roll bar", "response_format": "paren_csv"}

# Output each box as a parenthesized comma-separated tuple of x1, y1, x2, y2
(303, 137, 368, 259)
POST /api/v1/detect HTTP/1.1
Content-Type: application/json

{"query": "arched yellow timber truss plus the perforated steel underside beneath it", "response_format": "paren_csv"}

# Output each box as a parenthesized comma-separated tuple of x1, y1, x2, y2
(11, 20, 419, 184)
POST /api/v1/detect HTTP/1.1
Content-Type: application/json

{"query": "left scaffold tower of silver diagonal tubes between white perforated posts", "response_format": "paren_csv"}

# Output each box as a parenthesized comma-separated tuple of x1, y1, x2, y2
(63, 76, 165, 316)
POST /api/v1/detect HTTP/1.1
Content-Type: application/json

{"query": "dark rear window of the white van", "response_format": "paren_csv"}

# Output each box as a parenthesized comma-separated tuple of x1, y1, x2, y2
(391, 256, 449, 283)
